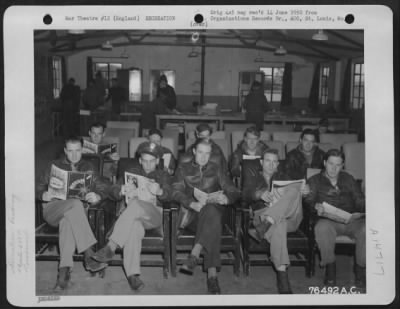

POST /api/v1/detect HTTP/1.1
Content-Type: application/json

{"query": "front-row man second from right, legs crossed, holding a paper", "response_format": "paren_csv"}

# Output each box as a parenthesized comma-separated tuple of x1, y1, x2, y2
(243, 148, 309, 294)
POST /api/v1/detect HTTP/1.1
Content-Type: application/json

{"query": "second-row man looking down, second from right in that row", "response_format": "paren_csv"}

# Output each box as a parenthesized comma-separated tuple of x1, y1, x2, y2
(230, 127, 268, 177)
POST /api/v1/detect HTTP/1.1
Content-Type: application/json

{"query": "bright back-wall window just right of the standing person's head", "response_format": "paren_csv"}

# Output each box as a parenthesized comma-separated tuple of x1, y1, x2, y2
(260, 66, 284, 103)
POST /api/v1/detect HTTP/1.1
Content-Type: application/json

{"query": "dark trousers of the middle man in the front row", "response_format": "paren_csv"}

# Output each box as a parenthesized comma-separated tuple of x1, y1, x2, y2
(186, 204, 226, 269)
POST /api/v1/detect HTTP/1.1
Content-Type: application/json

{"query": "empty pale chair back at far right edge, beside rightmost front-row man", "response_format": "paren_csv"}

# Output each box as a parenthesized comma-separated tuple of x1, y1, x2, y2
(343, 143, 365, 181)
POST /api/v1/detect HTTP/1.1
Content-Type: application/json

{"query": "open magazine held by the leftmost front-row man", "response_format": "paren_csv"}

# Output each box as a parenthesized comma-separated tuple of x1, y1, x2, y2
(48, 164, 93, 200)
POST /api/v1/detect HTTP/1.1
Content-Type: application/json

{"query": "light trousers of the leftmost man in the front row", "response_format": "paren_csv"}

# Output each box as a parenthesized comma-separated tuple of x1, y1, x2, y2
(43, 199, 97, 267)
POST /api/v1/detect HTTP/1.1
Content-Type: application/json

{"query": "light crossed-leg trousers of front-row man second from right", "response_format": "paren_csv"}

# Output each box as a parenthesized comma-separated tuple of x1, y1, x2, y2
(254, 188, 303, 267)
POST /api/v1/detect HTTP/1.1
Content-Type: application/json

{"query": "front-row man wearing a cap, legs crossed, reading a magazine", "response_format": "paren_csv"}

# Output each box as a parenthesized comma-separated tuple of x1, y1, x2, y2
(92, 142, 171, 291)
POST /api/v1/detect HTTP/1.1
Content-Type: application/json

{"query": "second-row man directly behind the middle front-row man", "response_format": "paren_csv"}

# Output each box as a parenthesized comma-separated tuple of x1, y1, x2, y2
(179, 123, 228, 172)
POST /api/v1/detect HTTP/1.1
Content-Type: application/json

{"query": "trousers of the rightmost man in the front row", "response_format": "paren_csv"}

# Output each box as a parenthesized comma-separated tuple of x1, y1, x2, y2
(314, 218, 366, 267)
